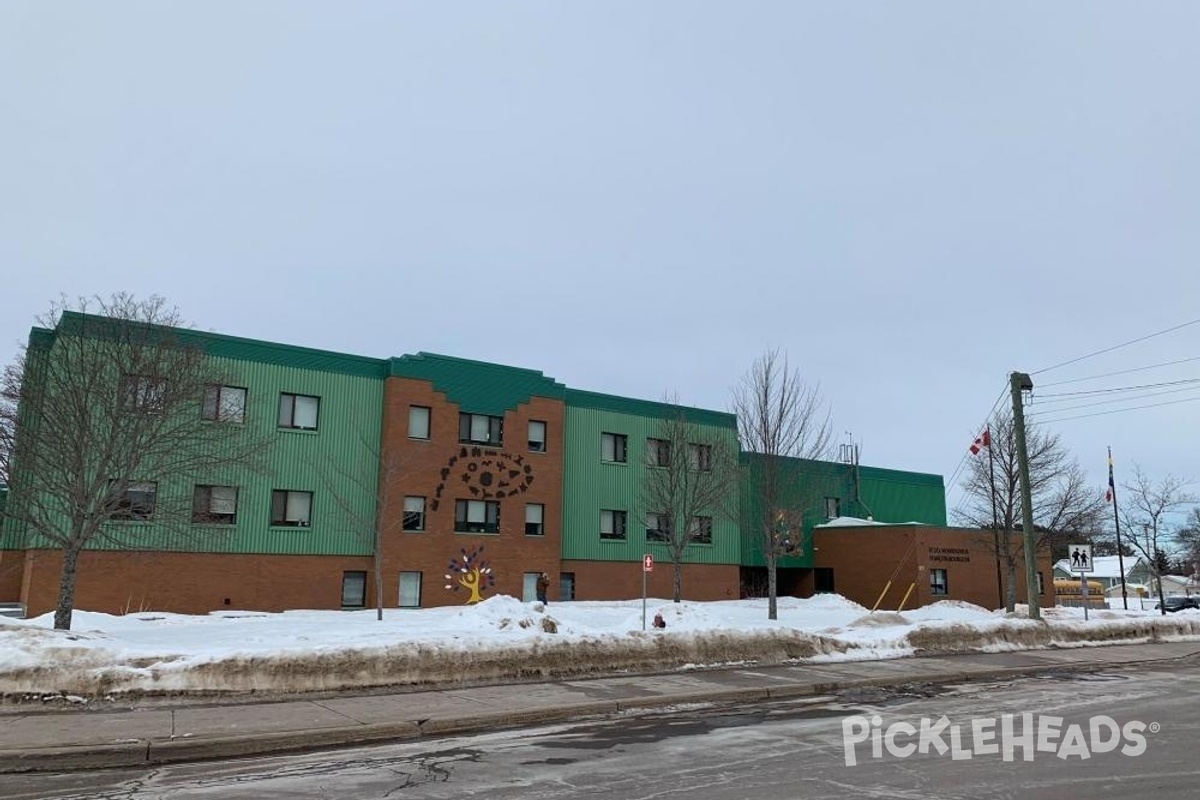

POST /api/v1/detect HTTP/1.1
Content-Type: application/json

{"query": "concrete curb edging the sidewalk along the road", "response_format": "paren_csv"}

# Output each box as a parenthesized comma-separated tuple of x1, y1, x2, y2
(0, 658, 1142, 774)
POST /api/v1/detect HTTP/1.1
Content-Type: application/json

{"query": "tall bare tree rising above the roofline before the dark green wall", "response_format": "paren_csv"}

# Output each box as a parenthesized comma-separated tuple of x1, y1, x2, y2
(732, 349, 833, 619)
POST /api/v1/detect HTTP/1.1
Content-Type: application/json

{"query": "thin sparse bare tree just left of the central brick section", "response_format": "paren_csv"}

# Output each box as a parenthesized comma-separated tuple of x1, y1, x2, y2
(313, 429, 410, 621)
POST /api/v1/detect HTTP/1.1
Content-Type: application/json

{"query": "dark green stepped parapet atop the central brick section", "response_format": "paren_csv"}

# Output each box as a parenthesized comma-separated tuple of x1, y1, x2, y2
(389, 353, 566, 416)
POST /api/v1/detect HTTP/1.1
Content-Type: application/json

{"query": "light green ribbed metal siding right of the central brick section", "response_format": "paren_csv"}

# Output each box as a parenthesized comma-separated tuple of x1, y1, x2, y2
(563, 407, 740, 564)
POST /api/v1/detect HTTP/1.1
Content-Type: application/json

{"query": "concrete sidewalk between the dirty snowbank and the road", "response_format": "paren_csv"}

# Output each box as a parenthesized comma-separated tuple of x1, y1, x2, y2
(0, 643, 1200, 772)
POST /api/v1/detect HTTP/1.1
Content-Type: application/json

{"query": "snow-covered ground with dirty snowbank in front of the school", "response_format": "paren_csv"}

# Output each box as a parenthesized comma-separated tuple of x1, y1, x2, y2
(0, 595, 1200, 697)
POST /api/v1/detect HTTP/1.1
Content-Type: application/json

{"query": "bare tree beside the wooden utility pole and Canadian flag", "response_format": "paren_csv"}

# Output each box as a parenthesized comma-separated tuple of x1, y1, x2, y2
(958, 413, 1104, 613)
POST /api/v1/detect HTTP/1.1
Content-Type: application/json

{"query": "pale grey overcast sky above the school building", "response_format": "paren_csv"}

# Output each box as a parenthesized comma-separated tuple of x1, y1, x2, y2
(0, 0, 1200, 515)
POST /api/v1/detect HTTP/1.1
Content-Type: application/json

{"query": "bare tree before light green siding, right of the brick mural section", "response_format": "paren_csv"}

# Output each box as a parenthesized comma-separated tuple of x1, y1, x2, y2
(641, 397, 738, 602)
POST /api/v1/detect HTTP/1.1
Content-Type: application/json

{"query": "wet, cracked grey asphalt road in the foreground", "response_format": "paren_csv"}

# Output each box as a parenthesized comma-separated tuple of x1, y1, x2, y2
(7, 660, 1200, 800)
